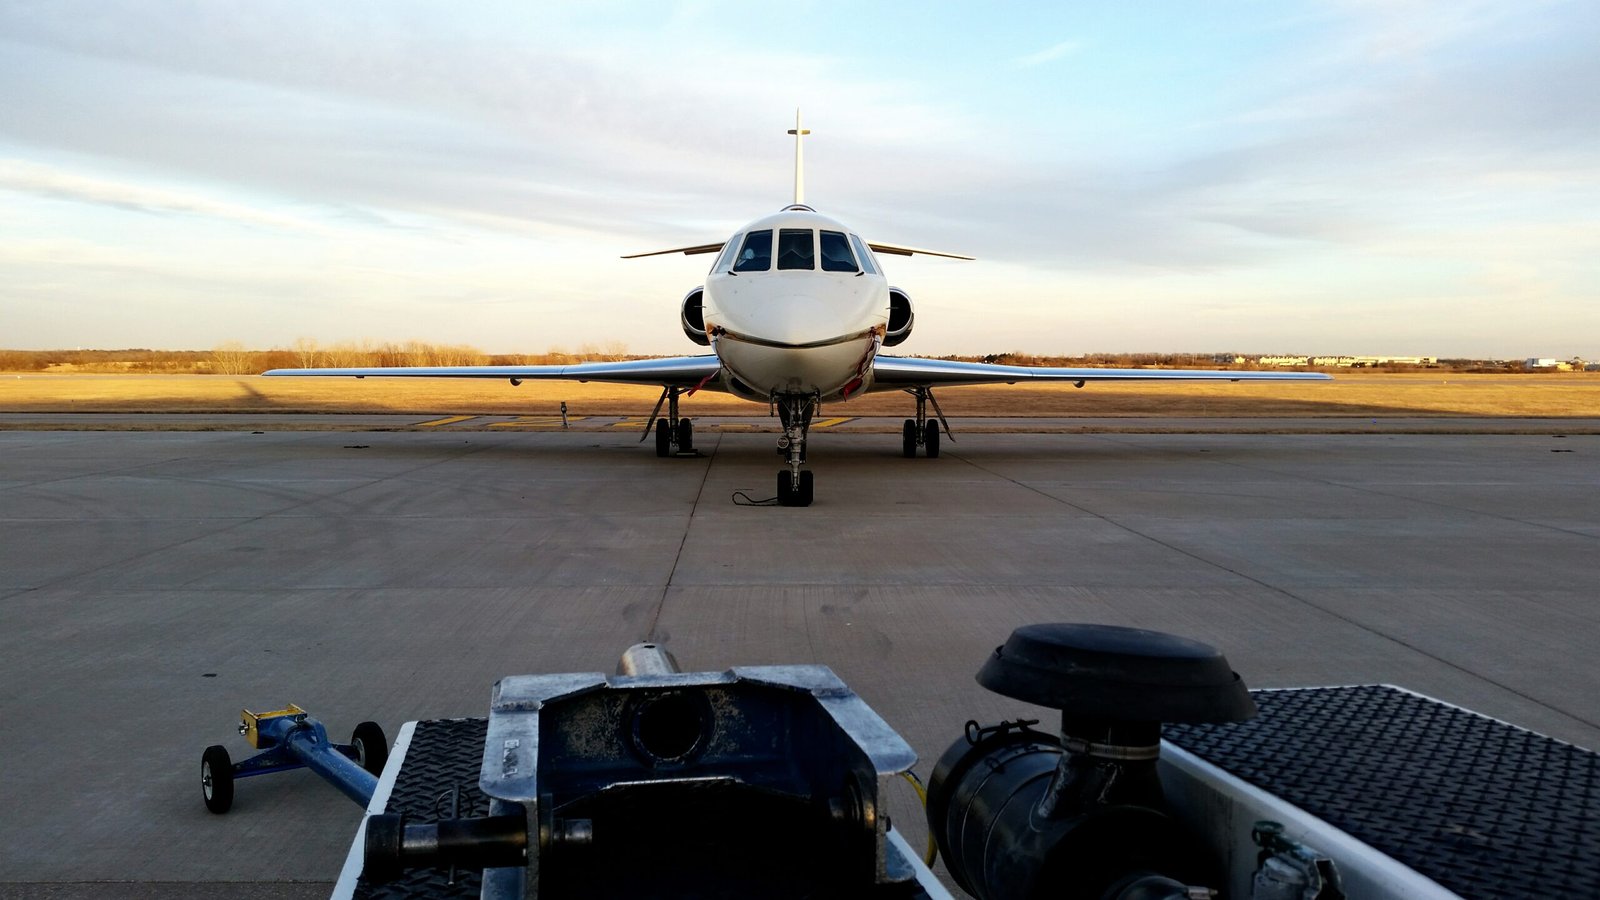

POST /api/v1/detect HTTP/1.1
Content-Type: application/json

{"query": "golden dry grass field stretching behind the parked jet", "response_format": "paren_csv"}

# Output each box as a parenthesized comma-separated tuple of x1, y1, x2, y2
(0, 372, 1600, 418)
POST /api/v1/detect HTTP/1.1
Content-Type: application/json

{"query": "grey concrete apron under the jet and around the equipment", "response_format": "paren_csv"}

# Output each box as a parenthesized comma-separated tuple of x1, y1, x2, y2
(0, 415, 1600, 898)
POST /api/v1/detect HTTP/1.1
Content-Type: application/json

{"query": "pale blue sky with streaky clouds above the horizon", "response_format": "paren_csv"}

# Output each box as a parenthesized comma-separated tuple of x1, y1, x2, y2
(0, 0, 1600, 359)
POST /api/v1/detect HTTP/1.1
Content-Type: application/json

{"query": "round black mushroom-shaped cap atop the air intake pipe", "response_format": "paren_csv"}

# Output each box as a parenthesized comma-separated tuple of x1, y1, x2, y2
(978, 623, 1256, 724)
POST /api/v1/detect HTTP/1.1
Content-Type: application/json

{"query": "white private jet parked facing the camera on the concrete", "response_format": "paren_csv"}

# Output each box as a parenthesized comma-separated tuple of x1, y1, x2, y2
(266, 112, 1328, 506)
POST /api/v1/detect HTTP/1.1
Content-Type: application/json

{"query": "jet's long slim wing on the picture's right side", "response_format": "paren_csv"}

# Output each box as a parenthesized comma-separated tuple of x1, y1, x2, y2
(872, 354, 1331, 391)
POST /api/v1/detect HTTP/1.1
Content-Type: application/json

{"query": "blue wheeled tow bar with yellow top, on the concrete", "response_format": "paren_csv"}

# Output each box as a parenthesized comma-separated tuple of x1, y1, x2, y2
(200, 703, 389, 815)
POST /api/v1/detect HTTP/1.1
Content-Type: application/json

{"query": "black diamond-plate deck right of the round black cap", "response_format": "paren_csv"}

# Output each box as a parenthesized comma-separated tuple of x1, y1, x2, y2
(1163, 685, 1600, 898)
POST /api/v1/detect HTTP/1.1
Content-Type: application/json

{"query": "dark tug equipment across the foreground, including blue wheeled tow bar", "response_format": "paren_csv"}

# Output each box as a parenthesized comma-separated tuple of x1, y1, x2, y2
(203, 625, 1600, 900)
